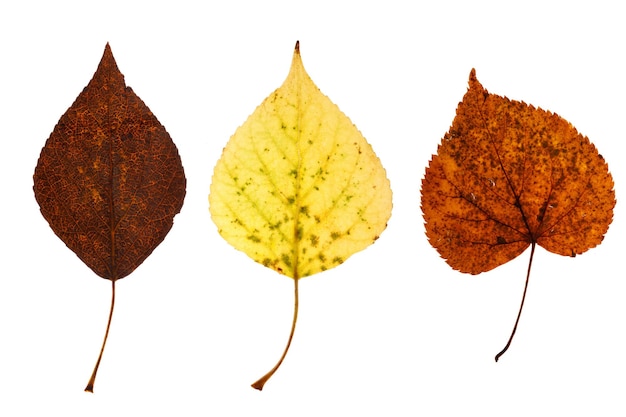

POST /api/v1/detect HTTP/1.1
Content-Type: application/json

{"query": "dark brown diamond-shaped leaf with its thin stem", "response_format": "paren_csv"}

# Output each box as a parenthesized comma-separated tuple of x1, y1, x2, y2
(34, 44, 186, 392)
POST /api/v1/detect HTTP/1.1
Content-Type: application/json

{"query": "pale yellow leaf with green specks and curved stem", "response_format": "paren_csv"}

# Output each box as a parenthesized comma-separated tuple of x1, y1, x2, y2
(209, 43, 391, 390)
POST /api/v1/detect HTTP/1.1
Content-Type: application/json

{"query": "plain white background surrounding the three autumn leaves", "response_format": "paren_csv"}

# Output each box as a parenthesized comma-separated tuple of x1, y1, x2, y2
(0, 0, 626, 416)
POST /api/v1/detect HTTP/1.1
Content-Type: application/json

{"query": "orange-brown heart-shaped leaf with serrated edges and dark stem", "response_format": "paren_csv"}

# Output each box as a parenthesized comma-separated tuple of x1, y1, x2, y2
(421, 70, 615, 361)
